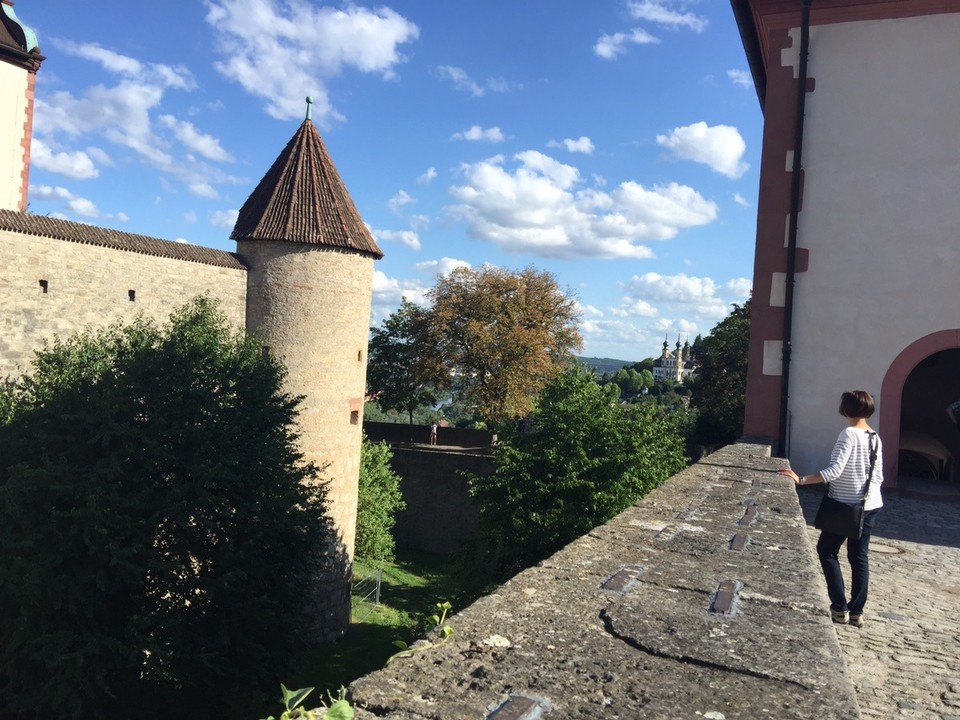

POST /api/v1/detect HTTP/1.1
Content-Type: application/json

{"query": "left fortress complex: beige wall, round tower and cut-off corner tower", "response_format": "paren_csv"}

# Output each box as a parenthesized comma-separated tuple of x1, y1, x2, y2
(0, 0, 383, 640)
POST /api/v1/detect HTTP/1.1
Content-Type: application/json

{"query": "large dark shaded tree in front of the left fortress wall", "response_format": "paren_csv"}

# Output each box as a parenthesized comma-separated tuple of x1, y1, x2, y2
(0, 298, 334, 718)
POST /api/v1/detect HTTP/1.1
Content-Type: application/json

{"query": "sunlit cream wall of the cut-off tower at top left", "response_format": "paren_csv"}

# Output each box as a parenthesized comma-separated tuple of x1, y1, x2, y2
(0, 62, 30, 210)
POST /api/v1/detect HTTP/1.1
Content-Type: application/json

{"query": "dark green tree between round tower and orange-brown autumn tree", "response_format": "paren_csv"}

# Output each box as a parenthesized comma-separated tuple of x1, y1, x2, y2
(367, 300, 450, 425)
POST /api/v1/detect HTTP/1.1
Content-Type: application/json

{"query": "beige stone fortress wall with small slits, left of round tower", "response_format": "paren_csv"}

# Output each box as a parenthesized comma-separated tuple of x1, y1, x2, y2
(0, 230, 247, 378)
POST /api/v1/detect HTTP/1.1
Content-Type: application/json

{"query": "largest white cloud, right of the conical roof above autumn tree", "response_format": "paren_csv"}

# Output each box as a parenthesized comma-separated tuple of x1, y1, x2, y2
(447, 150, 717, 258)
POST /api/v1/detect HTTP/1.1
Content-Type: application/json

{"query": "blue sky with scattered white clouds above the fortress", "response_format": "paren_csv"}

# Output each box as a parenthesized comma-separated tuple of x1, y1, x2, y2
(16, 0, 762, 361)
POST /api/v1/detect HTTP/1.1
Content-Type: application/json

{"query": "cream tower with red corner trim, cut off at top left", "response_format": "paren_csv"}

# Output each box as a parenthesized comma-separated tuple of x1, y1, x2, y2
(0, 0, 45, 211)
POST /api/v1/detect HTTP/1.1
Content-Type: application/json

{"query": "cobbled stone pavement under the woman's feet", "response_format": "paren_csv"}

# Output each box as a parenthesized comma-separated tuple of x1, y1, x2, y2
(800, 486, 960, 720)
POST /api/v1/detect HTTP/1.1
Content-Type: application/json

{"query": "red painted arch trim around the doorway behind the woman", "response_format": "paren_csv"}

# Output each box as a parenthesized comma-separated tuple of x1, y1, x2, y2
(879, 329, 960, 488)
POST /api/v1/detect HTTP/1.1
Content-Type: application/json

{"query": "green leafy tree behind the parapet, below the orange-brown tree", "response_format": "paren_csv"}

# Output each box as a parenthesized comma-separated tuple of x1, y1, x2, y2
(470, 365, 686, 576)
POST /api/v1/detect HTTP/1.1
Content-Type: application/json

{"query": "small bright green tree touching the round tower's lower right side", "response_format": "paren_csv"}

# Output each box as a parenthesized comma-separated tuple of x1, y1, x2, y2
(356, 436, 406, 562)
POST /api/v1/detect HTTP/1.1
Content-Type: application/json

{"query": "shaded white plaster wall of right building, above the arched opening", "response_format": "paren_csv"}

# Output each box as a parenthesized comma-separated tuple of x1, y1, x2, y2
(790, 15, 960, 472)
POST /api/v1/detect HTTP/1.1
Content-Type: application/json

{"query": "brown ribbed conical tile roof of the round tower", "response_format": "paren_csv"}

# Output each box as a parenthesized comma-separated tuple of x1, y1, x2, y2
(230, 118, 383, 259)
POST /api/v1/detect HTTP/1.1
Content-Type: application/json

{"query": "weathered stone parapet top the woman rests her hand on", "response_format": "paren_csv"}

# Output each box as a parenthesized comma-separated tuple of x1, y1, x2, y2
(342, 443, 859, 720)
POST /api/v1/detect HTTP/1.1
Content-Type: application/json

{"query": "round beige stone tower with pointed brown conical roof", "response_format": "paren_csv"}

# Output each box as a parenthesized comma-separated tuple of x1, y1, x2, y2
(230, 99, 383, 639)
